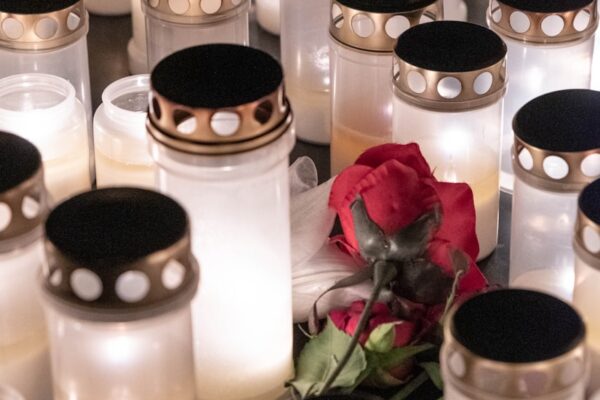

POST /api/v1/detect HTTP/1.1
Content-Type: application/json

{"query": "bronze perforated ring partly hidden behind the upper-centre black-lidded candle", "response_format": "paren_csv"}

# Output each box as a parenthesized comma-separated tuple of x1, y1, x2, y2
(329, 0, 443, 53)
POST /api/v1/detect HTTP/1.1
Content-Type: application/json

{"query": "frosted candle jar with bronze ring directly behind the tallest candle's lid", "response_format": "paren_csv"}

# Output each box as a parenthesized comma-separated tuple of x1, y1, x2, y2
(142, 0, 250, 69)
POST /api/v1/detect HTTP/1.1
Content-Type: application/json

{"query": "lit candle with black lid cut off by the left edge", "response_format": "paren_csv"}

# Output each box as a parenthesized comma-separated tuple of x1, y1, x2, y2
(0, 132, 51, 400)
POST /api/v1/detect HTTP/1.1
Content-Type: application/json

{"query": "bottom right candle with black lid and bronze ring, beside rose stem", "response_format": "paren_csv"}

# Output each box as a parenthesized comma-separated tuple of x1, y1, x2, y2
(440, 290, 589, 400)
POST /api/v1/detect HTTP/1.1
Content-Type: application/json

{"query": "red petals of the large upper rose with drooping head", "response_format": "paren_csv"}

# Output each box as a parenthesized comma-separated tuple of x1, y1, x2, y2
(329, 143, 487, 303)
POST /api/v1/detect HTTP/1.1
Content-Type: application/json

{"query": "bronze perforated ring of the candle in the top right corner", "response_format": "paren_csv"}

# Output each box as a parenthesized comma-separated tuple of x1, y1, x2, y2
(487, 0, 598, 44)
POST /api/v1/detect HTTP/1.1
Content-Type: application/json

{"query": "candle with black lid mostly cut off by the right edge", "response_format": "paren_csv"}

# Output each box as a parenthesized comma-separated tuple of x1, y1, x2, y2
(573, 180, 600, 390)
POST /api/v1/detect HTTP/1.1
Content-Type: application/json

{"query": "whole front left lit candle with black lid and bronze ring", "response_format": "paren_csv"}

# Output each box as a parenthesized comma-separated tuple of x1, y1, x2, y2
(41, 188, 199, 400)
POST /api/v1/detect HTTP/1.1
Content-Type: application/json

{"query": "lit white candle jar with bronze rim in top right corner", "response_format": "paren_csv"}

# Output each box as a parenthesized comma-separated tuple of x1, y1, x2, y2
(488, 0, 598, 192)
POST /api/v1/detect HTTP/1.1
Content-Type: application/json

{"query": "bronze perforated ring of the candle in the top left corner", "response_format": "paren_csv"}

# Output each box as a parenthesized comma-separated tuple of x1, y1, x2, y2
(0, 0, 88, 50)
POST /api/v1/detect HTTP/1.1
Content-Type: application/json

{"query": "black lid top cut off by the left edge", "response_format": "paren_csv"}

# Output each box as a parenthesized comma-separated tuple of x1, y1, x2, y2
(0, 132, 42, 193)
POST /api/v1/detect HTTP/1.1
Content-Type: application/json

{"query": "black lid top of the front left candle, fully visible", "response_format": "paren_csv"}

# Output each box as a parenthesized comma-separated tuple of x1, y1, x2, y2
(46, 188, 188, 268)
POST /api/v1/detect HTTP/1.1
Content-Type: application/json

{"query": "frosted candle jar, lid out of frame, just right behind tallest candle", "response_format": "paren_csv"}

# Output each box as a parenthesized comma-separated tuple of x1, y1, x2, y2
(281, 0, 331, 144)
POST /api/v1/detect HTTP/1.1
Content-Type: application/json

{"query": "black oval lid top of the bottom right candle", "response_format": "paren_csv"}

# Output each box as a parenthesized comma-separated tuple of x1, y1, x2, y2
(452, 290, 585, 363)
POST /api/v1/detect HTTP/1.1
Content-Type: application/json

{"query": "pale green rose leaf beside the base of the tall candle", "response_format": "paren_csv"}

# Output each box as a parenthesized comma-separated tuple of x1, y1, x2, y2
(288, 319, 367, 399)
